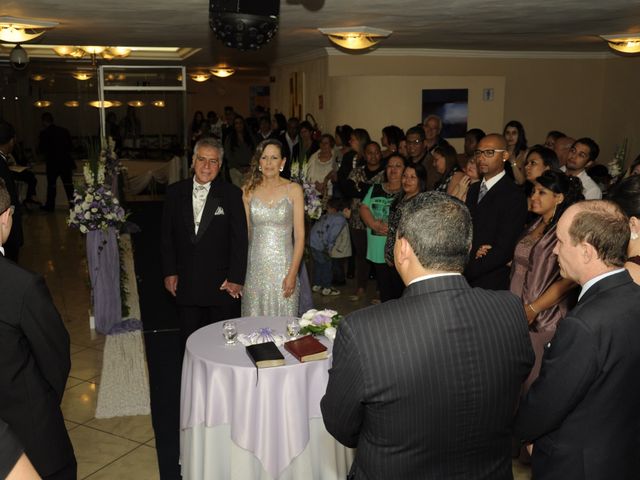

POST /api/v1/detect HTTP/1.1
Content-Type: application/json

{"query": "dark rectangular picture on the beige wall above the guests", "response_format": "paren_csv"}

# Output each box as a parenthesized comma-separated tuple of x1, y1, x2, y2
(420, 88, 469, 138)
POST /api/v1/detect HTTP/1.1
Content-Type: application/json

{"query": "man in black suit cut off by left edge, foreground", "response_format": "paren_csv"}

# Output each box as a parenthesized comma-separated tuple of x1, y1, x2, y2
(0, 181, 76, 480)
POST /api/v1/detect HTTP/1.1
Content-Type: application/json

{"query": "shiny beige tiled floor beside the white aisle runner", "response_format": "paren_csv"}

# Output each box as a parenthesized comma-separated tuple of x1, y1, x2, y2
(20, 210, 531, 480)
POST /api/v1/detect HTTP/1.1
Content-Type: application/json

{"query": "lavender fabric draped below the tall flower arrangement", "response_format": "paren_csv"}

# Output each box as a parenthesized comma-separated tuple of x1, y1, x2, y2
(87, 228, 122, 335)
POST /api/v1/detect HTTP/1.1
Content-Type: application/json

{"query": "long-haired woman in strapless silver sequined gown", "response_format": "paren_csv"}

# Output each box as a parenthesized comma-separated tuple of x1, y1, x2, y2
(242, 139, 304, 317)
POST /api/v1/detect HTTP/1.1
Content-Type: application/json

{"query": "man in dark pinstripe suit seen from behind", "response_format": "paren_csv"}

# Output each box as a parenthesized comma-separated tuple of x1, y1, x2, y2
(321, 192, 534, 480)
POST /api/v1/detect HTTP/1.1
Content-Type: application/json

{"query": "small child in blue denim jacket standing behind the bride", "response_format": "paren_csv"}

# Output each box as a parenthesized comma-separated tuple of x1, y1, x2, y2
(309, 198, 351, 296)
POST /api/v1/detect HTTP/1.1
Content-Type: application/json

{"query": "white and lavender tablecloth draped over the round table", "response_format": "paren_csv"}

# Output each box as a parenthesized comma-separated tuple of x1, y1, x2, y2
(180, 317, 353, 480)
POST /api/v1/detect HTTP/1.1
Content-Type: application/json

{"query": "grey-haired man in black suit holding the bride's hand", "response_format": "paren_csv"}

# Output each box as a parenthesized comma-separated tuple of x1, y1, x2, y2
(162, 138, 248, 344)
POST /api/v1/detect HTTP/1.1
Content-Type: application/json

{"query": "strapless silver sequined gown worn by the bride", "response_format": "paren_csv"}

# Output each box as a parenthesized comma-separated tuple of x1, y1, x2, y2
(242, 197, 299, 317)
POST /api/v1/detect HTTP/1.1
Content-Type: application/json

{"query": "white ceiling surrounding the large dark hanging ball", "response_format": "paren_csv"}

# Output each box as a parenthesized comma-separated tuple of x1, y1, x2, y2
(0, 0, 640, 68)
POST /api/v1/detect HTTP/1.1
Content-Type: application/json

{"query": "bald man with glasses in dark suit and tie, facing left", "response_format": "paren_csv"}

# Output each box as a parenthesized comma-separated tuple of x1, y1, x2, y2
(464, 133, 527, 290)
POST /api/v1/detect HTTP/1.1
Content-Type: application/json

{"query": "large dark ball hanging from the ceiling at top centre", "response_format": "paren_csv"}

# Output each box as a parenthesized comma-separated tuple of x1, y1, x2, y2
(209, 0, 280, 50)
